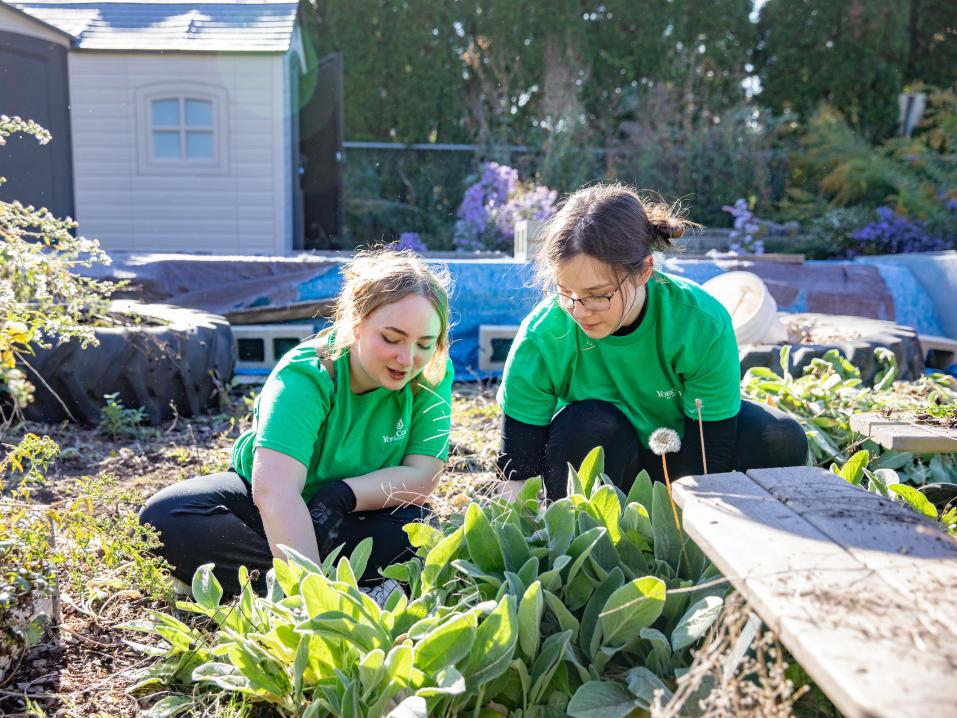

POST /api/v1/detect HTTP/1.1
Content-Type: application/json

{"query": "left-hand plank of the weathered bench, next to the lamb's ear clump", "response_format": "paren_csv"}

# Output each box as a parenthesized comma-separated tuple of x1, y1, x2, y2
(674, 473, 957, 718)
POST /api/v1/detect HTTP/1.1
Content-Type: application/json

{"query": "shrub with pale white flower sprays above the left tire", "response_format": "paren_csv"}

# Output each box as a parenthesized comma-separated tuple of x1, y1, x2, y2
(0, 115, 113, 424)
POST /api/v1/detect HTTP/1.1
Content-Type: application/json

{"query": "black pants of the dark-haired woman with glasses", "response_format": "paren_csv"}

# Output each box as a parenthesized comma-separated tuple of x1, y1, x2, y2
(544, 399, 808, 499)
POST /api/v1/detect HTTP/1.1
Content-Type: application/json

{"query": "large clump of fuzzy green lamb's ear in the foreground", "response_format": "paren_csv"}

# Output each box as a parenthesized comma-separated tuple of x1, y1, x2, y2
(127, 449, 725, 718)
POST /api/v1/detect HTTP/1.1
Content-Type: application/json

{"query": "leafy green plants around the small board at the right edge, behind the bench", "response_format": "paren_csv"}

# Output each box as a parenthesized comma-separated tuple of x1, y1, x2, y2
(741, 346, 957, 485)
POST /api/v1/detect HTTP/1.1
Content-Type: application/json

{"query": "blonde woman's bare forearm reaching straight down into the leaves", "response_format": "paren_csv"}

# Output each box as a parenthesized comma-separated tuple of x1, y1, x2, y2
(252, 447, 321, 563)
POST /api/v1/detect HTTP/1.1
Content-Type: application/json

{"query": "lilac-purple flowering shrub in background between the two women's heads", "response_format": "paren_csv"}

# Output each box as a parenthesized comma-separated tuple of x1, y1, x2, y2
(454, 162, 558, 251)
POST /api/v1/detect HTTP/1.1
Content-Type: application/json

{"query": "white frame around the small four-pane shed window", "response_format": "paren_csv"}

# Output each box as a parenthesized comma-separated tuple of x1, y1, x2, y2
(136, 82, 229, 176)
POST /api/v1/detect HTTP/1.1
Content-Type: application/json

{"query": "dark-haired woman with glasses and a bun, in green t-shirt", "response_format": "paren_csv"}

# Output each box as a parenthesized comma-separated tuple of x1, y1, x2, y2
(498, 184, 807, 499)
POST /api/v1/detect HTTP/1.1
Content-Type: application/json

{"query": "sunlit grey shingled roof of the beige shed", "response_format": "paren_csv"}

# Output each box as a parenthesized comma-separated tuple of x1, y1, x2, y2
(8, 0, 298, 52)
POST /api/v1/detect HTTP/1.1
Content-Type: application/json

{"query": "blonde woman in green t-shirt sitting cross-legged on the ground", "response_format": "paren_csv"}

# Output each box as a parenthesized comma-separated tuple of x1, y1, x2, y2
(140, 250, 453, 593)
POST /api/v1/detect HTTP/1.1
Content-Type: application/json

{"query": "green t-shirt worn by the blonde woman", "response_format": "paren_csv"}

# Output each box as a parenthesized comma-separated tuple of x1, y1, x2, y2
(232, 340, 453, 501)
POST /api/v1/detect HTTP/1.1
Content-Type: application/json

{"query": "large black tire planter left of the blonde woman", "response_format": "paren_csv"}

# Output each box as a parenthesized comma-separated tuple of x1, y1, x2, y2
(25, 300, 236, 425)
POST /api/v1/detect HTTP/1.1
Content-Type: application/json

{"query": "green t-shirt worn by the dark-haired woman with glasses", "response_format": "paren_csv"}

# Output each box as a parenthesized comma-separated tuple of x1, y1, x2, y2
(498, 272, 741, 446)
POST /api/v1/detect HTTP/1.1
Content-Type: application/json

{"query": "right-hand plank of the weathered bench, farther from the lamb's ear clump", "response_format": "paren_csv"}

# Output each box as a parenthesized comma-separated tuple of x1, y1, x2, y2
(748, 466, 957, 640)
